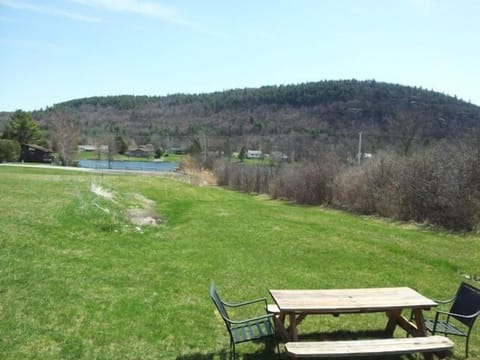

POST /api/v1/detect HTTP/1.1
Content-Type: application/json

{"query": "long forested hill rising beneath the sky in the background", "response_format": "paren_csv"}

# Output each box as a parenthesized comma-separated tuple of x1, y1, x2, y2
(3, 80, 480, 150)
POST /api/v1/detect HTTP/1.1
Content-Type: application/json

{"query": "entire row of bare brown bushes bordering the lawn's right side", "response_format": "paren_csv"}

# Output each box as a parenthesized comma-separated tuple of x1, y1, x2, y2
(214, 140, 480, 231)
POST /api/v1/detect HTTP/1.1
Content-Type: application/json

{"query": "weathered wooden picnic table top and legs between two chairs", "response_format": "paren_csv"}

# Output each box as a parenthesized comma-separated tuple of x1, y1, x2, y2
(270, 287, 437, 341)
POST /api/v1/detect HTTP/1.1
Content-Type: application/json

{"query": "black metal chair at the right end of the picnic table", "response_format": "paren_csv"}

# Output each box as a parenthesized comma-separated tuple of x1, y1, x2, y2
(425, 282, 480, 357)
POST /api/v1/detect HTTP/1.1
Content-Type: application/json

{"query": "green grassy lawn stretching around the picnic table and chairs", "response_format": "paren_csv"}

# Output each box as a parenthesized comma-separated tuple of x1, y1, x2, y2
(0, 166, 480, 360)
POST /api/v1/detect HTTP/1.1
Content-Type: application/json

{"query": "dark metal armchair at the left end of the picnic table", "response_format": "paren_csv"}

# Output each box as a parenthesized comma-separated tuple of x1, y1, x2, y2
(210, 284, 280, 359)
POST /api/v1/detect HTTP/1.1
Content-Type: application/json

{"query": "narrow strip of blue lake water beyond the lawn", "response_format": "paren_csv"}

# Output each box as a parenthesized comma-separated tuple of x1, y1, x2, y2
(78, 160, 178, 172)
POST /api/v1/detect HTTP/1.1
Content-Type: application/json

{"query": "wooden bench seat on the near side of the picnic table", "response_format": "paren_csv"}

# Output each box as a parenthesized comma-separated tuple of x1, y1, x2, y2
(285, 336, 453, 358)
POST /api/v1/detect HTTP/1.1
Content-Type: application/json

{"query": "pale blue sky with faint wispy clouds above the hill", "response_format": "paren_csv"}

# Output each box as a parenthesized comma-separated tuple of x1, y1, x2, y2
(0, 0, 480, 111)
